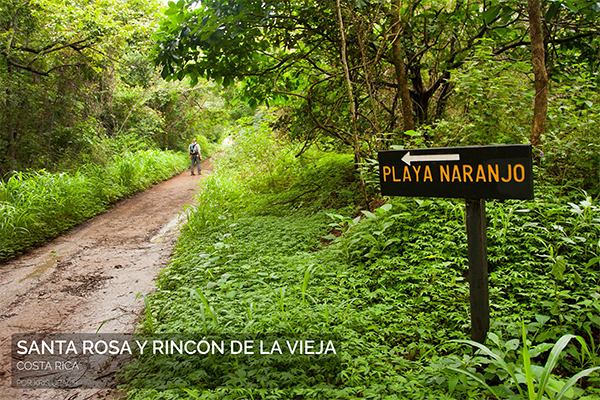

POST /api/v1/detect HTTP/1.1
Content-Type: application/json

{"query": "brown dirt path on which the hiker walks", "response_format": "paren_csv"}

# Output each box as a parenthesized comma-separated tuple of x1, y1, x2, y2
(0, 160, 211, 400)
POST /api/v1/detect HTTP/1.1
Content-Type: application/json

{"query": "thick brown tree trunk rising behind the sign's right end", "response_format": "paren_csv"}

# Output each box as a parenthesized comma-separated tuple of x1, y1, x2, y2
(527, 0, 548, 146)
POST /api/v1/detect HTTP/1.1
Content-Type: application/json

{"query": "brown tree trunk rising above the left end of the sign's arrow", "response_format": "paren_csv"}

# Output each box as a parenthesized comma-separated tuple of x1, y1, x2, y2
(391, 0, 415, 132)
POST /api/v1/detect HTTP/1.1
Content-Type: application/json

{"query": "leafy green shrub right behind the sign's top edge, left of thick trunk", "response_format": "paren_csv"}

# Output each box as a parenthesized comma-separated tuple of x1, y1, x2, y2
(434, 44, 534, 147)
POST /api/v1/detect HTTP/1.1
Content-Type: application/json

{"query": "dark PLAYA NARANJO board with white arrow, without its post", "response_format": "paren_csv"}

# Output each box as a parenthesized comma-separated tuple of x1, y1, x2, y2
(378, 145, 533, 199)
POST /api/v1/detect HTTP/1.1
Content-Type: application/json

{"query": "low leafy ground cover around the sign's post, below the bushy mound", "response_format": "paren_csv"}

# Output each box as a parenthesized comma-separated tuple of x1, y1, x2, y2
(129, 186, 600, 399)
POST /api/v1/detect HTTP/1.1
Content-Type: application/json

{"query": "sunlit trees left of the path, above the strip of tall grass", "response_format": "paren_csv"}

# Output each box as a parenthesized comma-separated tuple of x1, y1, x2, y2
(0, 0, 230, 179)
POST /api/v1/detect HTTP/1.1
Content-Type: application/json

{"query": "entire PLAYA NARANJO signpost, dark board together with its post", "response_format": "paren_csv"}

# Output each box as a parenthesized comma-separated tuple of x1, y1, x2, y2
(378, 145, 533, 343)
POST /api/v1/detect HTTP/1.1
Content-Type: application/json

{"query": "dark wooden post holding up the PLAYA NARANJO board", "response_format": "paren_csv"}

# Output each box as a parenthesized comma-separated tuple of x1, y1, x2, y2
(466, 199, 490, 343)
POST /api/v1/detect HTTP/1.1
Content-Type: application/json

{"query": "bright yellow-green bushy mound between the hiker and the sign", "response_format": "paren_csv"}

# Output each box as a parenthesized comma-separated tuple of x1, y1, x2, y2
(215, 114, 359, 215)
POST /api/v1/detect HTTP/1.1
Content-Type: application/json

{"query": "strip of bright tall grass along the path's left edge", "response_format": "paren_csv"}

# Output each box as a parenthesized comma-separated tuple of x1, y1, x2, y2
(0, 150, 188, 261)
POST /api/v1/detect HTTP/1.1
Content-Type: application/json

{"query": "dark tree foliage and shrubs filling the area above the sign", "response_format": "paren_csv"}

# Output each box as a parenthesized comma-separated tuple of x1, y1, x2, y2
(154, 0, 600, 158)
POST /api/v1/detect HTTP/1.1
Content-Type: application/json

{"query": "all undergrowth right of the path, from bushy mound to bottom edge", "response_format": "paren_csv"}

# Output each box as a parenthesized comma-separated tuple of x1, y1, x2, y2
(126, 120, 600, 399)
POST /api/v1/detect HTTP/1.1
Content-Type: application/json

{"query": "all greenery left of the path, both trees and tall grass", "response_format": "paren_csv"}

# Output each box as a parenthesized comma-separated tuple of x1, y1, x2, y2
(0, 0, 234, 259)
